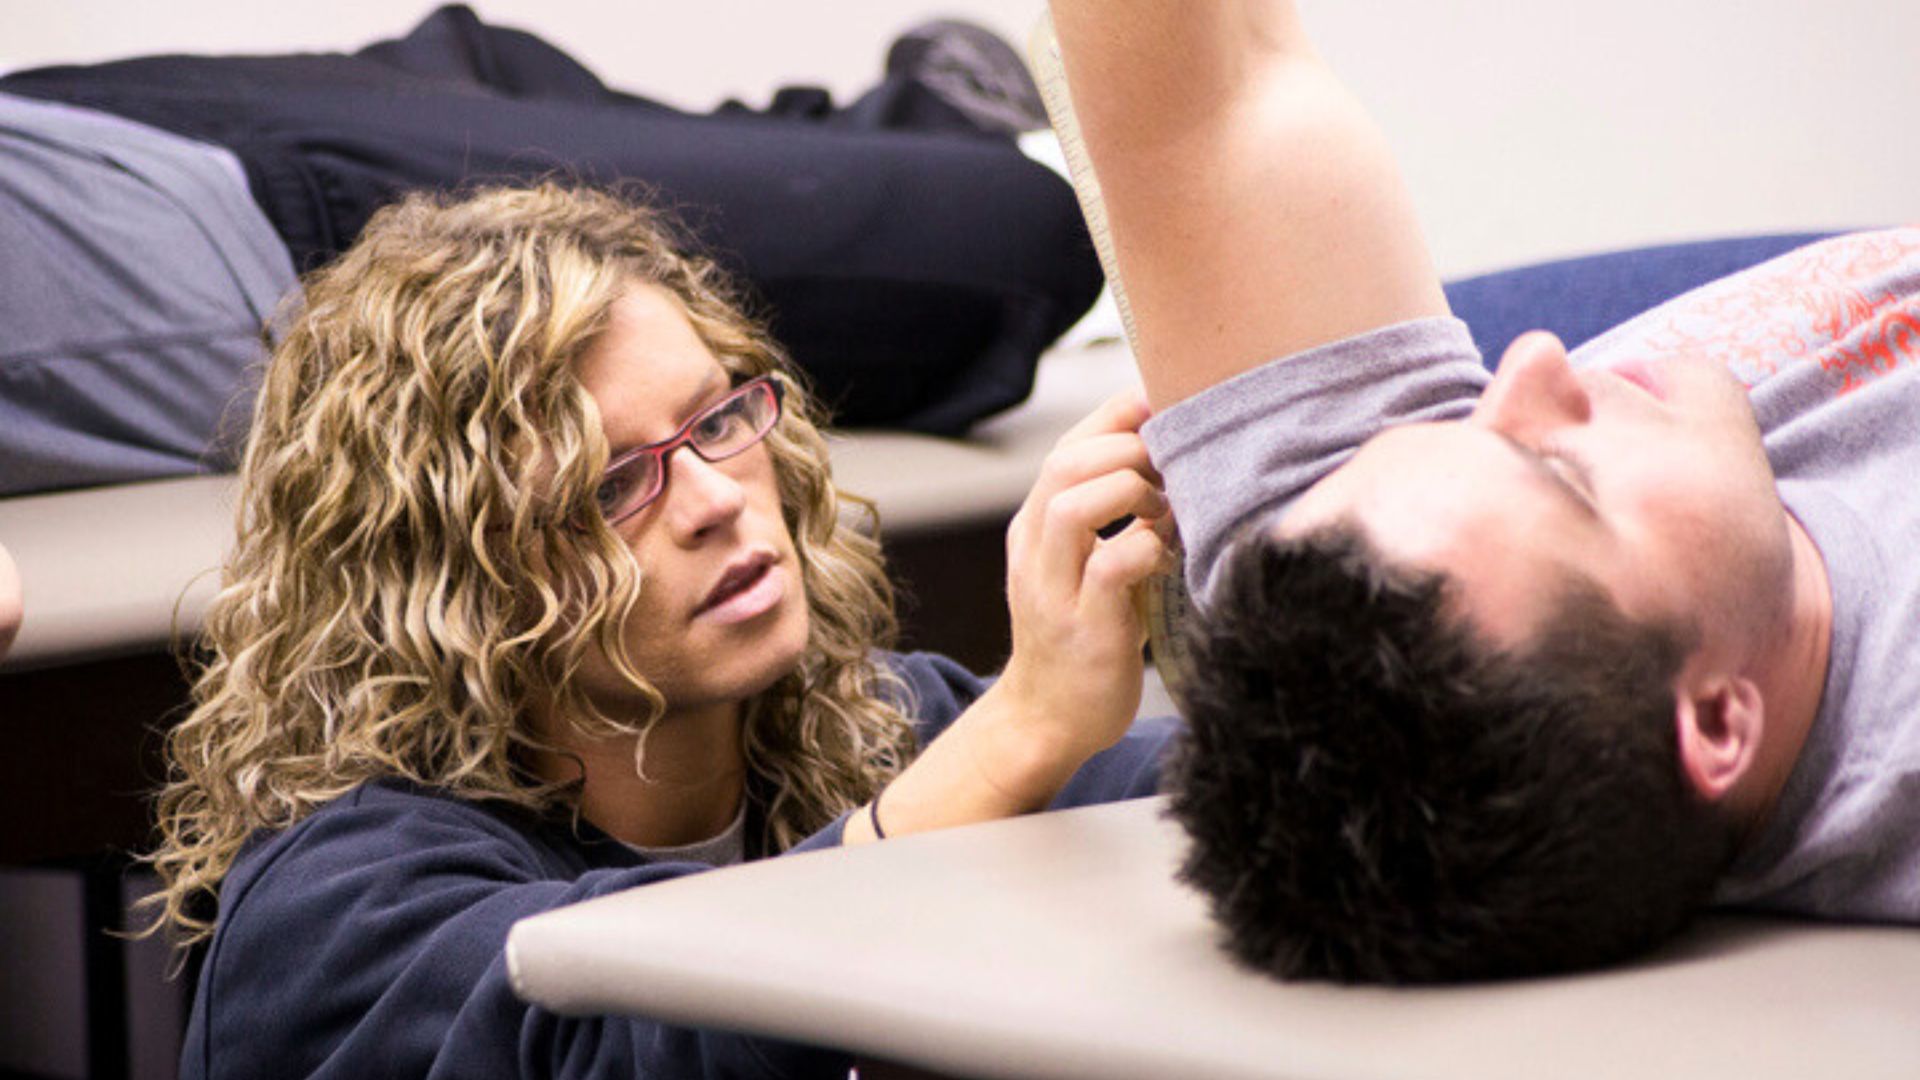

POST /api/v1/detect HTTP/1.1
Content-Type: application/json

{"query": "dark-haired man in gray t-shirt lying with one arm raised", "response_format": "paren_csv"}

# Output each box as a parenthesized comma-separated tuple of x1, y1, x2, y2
(1054, 0, 1920, 982)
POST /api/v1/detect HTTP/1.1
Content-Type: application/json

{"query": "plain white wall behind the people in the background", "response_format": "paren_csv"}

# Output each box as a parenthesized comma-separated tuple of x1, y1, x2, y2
(0, 0, 1920, 273)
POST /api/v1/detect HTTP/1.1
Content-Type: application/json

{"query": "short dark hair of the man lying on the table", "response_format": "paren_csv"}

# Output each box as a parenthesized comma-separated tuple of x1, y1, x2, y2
(1169, 527, 1734, 982)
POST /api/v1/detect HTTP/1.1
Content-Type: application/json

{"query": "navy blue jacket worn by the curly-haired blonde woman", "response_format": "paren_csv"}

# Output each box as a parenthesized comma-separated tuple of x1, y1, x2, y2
(180, 653, 1173, 1080)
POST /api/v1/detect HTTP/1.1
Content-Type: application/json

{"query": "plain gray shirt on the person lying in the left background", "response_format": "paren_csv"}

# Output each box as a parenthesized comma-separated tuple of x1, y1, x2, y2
(0, 94, 294, 494)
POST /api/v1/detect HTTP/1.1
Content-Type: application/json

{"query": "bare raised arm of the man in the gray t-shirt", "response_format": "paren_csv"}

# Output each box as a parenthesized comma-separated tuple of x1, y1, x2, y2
(1052, 0, 1448, 407)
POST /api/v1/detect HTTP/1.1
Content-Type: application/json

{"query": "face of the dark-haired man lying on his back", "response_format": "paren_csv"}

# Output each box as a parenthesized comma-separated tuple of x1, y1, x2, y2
(1279, 334, 1791, 663)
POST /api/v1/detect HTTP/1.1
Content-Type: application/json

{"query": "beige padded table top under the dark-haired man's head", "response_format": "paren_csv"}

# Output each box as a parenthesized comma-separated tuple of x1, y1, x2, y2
(507, 799, 1920, 1080)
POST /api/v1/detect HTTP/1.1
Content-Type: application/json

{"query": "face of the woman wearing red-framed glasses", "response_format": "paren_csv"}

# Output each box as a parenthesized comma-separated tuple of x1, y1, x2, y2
(574, 282, 808, 717)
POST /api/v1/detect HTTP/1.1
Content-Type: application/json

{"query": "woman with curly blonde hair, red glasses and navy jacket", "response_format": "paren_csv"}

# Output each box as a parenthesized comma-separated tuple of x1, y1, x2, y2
(154, 184, 1167, 1078)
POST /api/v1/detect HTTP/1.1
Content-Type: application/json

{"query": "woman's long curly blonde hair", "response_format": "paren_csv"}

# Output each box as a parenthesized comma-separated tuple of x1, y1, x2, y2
(152, 184, 914, 945)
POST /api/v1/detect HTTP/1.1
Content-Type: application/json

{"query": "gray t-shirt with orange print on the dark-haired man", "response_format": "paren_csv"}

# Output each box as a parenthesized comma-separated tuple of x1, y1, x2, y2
(1144, 229, 1920, 922)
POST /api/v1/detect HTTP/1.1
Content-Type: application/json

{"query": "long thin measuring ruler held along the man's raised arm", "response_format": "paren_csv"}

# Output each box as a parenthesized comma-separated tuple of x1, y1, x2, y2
(1027, 12, 1194, 711)
